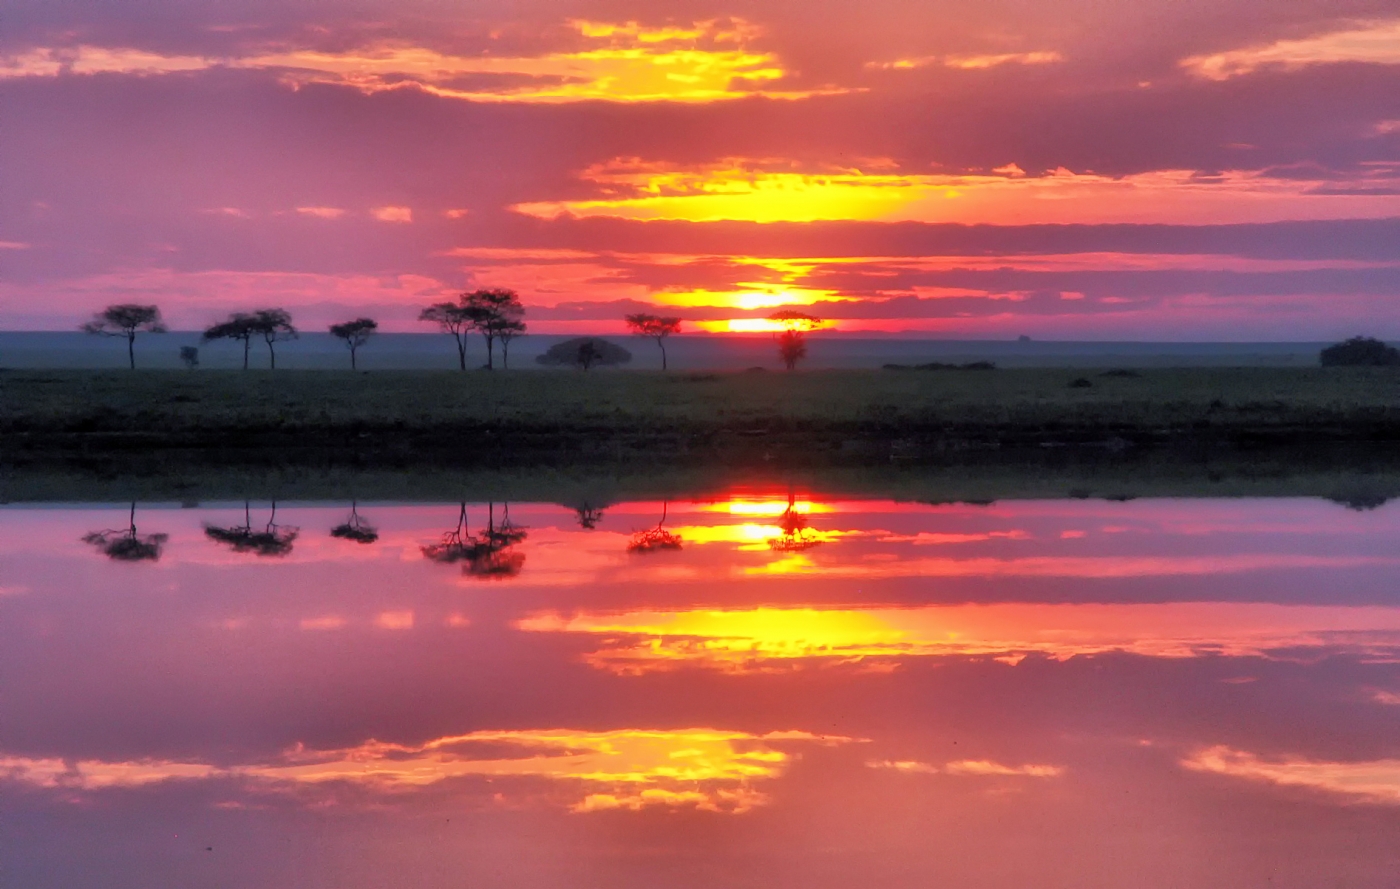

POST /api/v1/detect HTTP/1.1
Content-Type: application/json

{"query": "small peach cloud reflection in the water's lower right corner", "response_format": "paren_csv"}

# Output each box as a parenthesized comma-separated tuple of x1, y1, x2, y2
(1182, 746, 1400, 805)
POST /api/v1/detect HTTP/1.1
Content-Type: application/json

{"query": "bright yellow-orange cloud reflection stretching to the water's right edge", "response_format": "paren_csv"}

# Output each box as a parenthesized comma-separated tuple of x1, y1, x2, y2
(517, 604, 1400, 673)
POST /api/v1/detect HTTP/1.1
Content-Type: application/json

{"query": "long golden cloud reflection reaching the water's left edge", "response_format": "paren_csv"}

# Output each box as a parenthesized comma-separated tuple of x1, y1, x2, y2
(0, 728, 850, 812)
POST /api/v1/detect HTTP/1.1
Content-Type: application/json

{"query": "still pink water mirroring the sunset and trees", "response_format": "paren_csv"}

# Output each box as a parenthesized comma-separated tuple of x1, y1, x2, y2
(0, 498, 1400, 889)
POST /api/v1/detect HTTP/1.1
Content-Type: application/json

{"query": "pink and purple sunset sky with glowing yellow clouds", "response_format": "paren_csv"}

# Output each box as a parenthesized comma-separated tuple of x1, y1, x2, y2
(0, 0, 1400, 340)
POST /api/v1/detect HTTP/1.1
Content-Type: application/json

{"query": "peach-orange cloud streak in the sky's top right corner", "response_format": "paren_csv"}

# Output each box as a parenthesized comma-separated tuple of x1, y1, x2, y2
(1180, 21, 1400, 80)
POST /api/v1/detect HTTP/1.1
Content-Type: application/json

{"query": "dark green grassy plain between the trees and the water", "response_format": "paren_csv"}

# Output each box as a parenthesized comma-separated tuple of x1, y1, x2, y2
(0, 368, 1400, 465)
